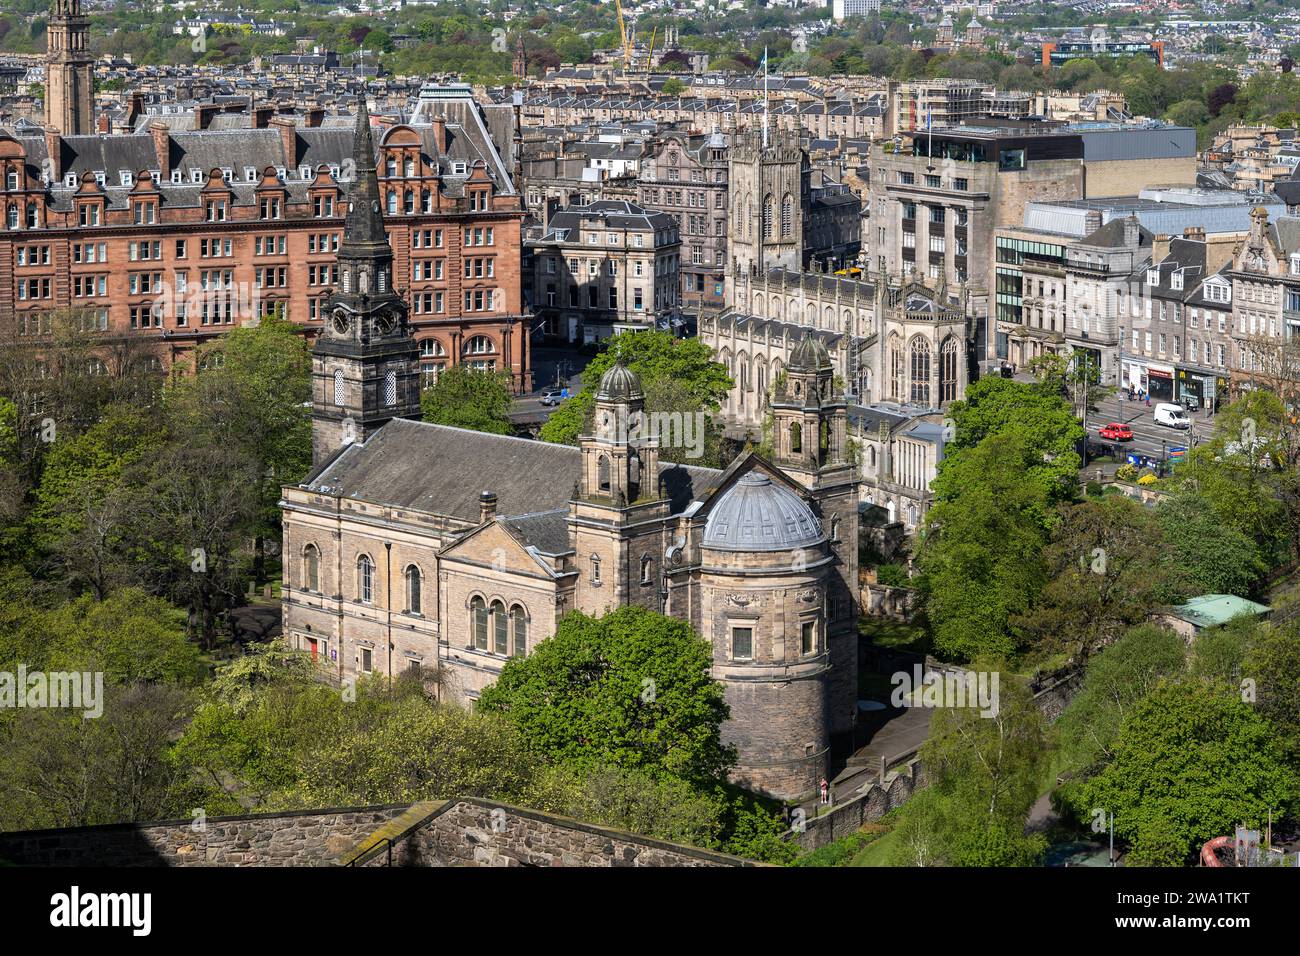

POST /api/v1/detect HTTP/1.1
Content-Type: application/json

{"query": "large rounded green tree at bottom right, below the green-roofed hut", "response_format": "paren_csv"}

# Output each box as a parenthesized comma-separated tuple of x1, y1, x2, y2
(1076, 680, 1300, 862)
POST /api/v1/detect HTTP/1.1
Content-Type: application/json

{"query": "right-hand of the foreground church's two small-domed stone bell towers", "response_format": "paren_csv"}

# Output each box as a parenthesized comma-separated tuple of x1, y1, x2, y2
(772, 333, 859, 754)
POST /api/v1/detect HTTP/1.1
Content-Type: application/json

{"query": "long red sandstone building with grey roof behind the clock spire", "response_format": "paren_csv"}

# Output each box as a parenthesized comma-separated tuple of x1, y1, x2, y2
(0, 79, 530, 389)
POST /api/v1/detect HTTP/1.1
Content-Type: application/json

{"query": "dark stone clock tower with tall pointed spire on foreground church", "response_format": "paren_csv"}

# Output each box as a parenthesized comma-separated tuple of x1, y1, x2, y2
(312, 96, 420, 467)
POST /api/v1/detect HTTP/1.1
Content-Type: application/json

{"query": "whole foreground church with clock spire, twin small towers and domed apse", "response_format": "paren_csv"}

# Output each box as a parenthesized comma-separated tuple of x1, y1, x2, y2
(282, 147, 858, 797)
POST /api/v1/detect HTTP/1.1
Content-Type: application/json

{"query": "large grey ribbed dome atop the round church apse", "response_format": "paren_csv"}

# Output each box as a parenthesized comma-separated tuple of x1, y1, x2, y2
(703, 471, 826, 551)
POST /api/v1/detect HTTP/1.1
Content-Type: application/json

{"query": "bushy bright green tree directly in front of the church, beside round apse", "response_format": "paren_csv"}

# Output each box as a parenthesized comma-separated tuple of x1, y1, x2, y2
(478, 606, 736, 782)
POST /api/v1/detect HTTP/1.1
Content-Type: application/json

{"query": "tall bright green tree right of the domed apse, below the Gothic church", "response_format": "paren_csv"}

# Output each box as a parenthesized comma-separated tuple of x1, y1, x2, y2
(918, 433, 1050, 658)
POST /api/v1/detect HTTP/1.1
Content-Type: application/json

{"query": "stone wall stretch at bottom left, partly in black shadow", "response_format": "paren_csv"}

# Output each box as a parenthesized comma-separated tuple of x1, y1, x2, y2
(0, 804, 406, 866)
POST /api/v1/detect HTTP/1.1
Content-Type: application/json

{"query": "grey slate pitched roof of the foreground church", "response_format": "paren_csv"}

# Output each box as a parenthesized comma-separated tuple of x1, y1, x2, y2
(306, 419, 720, 524)
